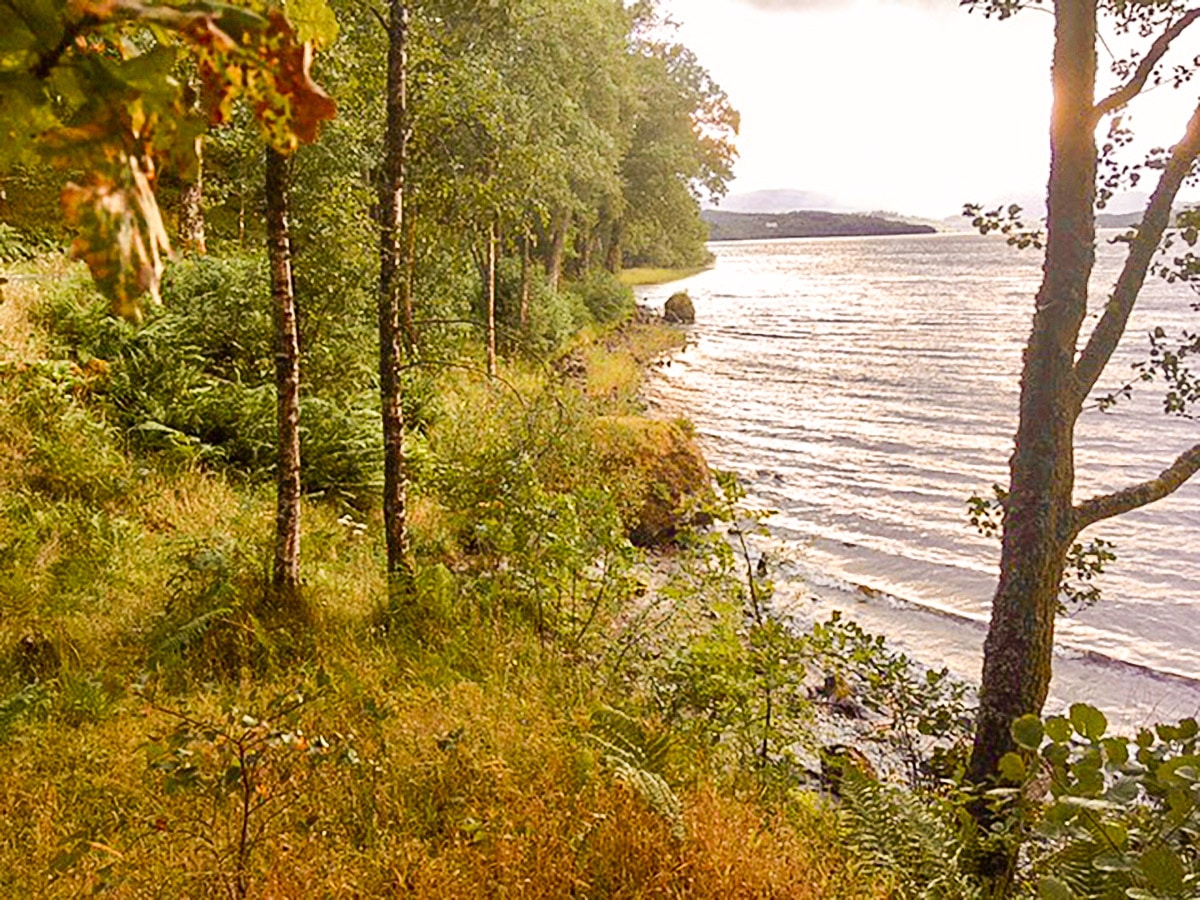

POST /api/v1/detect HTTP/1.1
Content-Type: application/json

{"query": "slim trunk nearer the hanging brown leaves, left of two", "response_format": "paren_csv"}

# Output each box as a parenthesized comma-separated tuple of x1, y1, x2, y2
(266, 149, 300, 611)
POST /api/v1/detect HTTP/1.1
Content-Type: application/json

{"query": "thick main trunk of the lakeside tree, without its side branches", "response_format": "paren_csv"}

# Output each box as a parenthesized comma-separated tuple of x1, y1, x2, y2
(970, 0, 1097, 784)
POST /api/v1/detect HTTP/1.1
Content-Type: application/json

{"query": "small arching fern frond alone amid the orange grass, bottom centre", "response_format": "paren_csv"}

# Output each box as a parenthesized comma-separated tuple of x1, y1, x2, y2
(587, 707, 686, 838)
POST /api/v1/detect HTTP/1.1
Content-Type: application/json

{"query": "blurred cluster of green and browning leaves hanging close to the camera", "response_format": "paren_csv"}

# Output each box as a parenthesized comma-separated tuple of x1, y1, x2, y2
(8, 0, 336, 318)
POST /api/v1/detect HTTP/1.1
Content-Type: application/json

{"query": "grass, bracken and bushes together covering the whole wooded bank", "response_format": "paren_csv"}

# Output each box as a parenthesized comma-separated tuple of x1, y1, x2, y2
(0, 256, 888, 900)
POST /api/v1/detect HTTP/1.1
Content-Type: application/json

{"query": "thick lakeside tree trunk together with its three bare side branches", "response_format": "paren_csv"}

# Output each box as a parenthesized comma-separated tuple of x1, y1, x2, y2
(968, 0, 1200, 784)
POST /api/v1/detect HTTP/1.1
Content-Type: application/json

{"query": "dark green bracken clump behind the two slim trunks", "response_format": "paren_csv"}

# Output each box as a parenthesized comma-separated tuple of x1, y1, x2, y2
(38, 258, 388, 503)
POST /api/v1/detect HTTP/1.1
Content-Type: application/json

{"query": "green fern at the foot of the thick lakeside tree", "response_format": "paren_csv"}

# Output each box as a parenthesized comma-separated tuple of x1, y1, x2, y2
(841, 766, 983, 900)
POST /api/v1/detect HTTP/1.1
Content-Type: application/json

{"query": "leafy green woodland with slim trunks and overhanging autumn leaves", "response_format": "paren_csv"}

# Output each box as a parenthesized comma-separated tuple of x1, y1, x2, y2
(0, 0, 738, 607)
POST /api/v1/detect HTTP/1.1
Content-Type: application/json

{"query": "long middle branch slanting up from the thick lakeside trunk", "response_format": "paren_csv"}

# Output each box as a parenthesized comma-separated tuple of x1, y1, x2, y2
(1075, 96, 1200, 404)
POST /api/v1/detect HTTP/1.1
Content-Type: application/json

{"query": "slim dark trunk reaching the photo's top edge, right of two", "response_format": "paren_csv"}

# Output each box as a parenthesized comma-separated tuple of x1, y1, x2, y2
(379, 0, 413, 599)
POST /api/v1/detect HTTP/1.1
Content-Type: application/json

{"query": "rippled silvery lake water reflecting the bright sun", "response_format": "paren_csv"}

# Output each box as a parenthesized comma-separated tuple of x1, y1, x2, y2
(638, 233, 1200, 716)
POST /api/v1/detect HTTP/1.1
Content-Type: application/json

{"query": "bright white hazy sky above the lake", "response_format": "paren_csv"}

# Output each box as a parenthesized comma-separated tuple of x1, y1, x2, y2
(664, 0, 1196, 218)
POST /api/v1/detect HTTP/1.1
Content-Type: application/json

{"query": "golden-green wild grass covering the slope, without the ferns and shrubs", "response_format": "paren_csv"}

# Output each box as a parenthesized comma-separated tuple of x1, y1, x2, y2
(0, 256, 884, 898)
